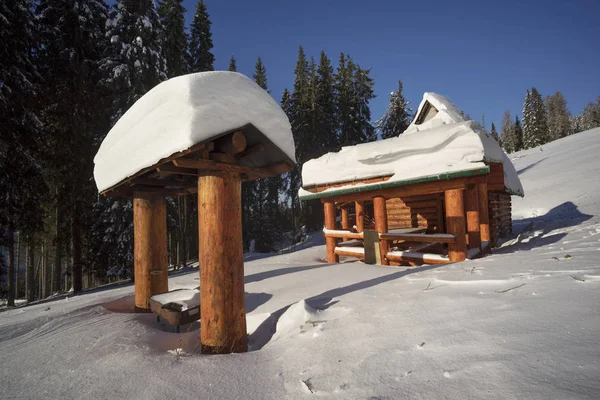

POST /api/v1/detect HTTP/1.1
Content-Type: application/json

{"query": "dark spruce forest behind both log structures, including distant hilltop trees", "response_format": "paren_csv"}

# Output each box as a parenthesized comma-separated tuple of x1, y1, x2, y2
(0, 0, 600, 306)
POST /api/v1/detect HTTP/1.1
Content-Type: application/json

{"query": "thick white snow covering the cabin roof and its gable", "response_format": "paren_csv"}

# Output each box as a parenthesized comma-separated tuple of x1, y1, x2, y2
(300, 93, 524, 197)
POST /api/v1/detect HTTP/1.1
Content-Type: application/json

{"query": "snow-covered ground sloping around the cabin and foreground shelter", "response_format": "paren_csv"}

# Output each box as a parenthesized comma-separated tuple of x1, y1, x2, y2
(0, 129, 600, 399)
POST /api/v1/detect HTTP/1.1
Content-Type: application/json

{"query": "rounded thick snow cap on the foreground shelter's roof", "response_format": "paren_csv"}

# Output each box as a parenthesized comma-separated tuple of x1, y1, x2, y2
(94, 71, 295, 191)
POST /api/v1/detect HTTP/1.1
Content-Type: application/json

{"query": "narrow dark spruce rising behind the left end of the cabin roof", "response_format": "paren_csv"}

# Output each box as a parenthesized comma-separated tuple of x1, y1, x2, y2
(315, 50, 339, 152)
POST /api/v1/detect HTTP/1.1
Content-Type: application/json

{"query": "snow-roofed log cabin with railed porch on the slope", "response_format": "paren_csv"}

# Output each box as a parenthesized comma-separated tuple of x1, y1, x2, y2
(299, 93, 524, 265)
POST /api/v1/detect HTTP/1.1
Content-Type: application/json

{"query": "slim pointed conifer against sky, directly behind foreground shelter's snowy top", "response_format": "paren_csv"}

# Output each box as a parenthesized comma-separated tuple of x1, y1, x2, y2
(189, 0, 215, 72)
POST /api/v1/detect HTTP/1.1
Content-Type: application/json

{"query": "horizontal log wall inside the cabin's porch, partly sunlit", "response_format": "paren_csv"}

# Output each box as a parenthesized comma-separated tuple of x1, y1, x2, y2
(386, 194, 444, 232)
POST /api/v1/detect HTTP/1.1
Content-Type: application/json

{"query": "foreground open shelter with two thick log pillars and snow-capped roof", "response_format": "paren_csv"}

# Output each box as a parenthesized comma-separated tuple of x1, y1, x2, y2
(94, 72, 295, 353)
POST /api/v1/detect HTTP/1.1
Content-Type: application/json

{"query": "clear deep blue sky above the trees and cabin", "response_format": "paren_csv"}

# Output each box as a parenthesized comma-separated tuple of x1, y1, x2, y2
(184, 0, 600, 129)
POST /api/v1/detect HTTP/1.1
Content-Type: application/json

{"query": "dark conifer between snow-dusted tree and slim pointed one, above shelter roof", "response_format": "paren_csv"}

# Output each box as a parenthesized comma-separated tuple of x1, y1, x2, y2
(157, 0, 189, 77)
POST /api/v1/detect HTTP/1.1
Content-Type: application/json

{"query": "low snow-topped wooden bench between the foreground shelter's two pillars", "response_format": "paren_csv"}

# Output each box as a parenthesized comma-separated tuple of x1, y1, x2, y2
(150, 289, 200, 333)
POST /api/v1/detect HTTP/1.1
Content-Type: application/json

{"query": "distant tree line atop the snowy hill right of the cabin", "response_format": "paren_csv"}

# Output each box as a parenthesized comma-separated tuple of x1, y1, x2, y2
(490, 87, 600, 153)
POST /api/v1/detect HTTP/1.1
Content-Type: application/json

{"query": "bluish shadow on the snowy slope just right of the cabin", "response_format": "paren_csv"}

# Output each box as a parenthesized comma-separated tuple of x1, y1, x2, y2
(493, 201, 594, 254)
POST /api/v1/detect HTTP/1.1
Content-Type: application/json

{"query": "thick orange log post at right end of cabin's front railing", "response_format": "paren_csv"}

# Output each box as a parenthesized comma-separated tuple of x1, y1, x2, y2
(444, 189, 467, 262)
